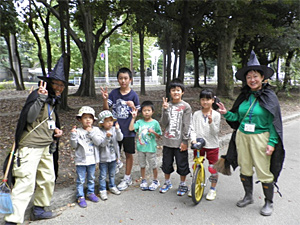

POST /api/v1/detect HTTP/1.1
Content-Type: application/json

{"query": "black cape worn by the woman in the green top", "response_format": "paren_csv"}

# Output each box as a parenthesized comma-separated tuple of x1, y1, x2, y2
(221, 84, 285, 183)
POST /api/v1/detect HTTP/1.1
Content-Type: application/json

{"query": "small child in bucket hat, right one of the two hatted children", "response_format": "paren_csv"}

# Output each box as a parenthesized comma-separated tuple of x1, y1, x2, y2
(98, 110, 123, 200)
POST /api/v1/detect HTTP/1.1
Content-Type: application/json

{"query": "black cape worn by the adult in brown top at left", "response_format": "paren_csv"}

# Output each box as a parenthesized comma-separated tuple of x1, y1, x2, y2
(3, 90, 60, 186)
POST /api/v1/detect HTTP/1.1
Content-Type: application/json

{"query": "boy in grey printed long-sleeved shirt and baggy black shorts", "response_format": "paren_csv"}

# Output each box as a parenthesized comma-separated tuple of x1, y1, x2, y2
(160, 79, 192, 196)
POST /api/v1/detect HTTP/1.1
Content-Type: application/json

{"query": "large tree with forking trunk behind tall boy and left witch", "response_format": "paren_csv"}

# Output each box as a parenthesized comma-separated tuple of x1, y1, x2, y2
(38, 0, 128, 97)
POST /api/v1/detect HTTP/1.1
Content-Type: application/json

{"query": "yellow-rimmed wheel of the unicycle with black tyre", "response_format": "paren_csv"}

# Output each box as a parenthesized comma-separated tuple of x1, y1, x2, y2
(192, 165, 205, 204)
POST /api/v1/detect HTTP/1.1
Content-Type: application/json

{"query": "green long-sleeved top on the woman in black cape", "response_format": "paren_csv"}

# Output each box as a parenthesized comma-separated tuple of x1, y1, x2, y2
(224, 94, 278, 147)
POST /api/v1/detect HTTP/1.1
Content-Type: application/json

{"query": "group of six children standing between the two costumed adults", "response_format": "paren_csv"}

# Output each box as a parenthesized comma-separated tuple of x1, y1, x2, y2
(71, 68, 220, 207)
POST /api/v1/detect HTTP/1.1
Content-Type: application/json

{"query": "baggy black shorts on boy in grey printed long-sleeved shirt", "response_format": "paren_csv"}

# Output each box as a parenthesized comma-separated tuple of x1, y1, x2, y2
(161, 146, 190, 176)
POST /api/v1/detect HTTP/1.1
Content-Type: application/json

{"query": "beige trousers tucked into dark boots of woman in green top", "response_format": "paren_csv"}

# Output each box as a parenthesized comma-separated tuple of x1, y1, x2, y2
(236, 130, 274, 183)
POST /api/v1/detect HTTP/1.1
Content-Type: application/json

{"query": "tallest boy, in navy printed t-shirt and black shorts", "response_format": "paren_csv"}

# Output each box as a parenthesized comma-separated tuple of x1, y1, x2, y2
(101, 68, 140, 191)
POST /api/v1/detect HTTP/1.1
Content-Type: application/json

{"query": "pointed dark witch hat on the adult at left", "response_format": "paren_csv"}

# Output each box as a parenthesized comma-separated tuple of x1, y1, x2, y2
(38, 55, 74, 86)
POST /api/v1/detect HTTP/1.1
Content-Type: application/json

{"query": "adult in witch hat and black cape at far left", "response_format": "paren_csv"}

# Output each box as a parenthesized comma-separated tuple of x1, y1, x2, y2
(5, 56, 72, 224)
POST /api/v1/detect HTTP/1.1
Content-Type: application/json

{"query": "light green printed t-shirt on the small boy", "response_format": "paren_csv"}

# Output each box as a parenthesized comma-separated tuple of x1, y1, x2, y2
(134, 119, 161, 152)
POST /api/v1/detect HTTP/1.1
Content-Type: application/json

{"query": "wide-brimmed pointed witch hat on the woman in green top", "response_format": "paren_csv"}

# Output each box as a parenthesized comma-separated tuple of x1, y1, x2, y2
(235, 50, 274, 81)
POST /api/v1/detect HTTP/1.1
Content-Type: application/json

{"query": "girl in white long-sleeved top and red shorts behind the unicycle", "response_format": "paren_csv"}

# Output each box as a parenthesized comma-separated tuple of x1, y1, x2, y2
(191, 89, 221, 201)
